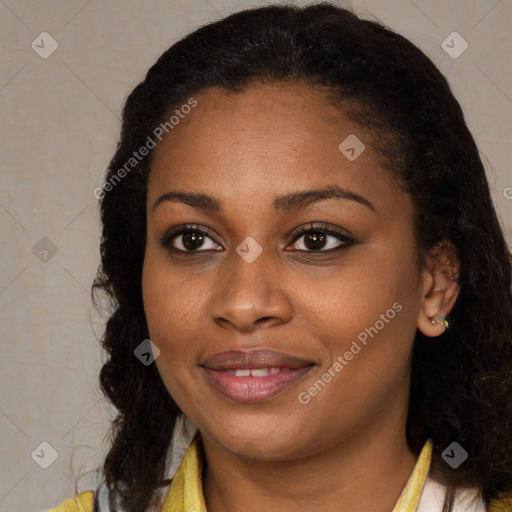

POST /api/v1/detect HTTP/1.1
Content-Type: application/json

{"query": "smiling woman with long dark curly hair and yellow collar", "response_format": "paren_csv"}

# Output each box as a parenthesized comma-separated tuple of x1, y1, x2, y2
(50, 3, 512, 512)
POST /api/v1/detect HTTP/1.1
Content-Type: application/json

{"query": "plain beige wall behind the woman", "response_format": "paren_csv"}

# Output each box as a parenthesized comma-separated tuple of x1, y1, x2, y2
(0, 0, 512, 512)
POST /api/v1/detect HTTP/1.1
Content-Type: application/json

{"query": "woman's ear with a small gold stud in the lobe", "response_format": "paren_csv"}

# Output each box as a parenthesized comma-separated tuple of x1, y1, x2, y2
(418, 241, 460, 337)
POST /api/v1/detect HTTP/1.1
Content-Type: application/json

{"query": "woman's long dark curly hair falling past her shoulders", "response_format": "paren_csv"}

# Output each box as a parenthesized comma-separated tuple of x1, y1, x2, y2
(92, 3, 512, 512)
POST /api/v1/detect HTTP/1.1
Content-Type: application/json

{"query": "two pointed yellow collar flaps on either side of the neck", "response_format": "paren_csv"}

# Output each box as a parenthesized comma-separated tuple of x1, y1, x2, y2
(161, 436, 432, 512)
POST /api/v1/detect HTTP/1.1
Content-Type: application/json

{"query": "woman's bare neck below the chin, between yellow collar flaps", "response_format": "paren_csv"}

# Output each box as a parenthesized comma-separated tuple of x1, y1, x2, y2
(202, 420, 417, 512)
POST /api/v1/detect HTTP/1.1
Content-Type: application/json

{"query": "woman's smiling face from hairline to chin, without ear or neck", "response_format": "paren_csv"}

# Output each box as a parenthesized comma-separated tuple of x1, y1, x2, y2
(143, 85, 424, 460)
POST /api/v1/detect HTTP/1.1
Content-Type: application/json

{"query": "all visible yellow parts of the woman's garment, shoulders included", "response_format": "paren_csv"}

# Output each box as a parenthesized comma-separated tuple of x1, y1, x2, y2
(47, 437, 512, 512)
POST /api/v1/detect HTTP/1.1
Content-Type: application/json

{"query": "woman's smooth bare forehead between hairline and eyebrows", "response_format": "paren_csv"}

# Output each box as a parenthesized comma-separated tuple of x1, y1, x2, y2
(148, 84, 406, 216)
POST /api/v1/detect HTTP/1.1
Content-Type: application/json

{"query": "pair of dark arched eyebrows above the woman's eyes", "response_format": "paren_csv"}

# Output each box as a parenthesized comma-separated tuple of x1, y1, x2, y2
(153, 185, 376, 213)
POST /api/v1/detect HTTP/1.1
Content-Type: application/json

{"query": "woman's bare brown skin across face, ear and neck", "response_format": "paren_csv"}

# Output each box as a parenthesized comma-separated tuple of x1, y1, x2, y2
(142, 84, 458, 512)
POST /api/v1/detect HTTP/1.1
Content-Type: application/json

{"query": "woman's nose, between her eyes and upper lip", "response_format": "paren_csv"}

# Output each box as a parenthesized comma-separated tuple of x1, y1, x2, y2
(211, 250, 293, 332)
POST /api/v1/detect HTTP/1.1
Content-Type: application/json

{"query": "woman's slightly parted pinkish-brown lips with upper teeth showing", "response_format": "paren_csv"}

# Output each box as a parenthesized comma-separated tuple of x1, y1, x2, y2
(200, 349, 316, 404)
